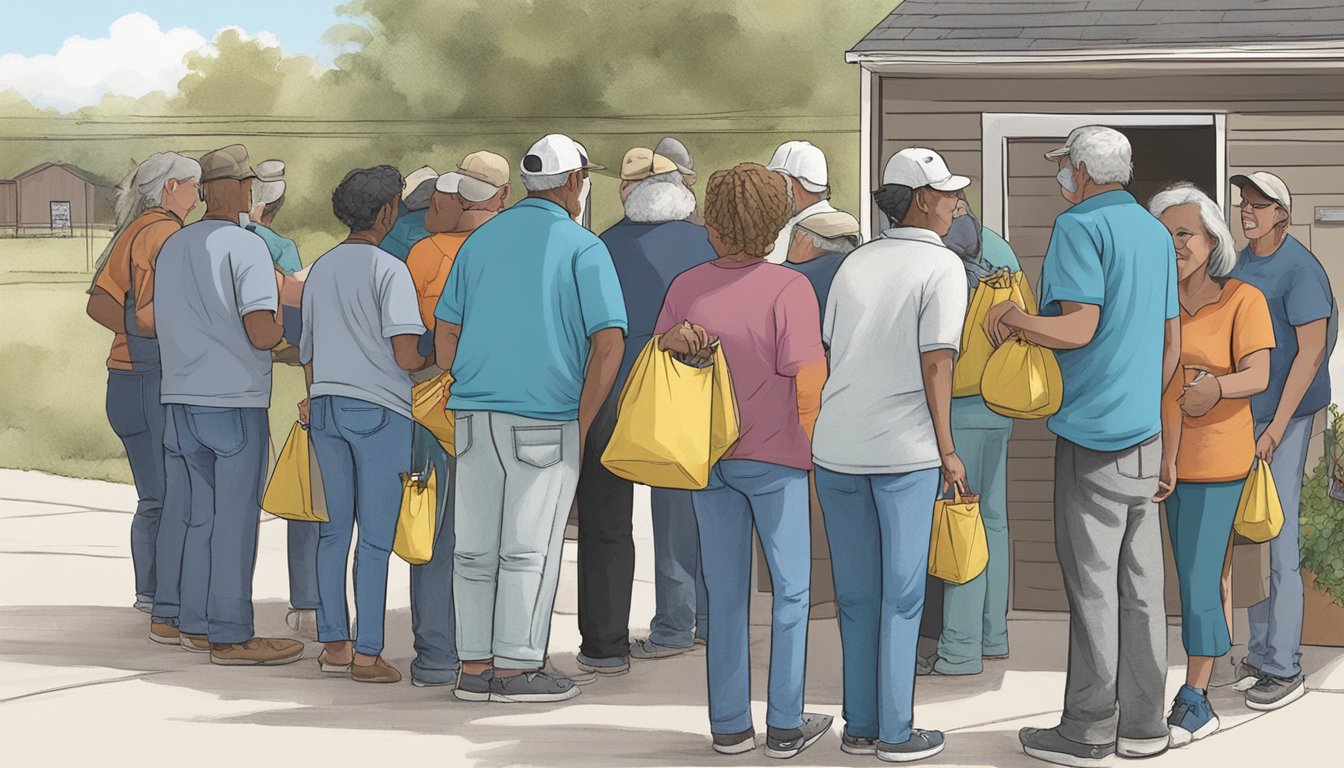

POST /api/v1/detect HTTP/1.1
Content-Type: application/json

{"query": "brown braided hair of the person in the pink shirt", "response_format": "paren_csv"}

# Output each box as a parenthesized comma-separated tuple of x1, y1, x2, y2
(704, 163, 793, 258)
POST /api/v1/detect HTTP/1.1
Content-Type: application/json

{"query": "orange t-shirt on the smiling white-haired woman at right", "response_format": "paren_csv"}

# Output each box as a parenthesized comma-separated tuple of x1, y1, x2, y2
(1163, 278, 1274, 483)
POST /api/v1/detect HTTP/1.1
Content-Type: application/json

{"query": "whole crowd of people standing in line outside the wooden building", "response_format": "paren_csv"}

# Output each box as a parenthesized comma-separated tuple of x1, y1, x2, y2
(89, 126, 1335, 764)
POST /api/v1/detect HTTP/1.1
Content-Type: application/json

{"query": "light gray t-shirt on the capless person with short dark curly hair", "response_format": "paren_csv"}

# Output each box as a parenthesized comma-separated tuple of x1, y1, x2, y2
(298, 243, 425, 418)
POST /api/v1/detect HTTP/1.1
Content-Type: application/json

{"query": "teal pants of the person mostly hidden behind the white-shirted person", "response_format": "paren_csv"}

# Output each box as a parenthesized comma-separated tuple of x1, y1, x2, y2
(921, 398, 1012, 675)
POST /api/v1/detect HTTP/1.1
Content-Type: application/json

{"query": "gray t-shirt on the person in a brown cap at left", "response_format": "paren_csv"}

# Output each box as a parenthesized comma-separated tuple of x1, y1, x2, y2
(155, 219, 280, 408)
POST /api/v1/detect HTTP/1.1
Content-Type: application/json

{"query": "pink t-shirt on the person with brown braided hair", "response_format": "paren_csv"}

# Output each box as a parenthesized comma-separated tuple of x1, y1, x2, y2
(655, 258, 825, 469)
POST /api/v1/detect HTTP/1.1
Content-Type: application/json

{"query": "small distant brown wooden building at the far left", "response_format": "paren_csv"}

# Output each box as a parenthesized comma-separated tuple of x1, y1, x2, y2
(0, 163, 113, 235)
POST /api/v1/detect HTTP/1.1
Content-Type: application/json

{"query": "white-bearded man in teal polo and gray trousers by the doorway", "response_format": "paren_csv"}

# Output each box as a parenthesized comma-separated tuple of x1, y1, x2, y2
(985, 125, 1180, 765)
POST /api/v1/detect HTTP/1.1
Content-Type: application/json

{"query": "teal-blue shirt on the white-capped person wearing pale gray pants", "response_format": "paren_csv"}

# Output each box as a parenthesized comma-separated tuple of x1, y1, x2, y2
(434, 198, 628, 421)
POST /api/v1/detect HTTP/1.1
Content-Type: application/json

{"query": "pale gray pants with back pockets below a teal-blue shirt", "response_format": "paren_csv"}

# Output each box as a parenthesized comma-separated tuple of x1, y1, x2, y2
(453, 412, 579, 670)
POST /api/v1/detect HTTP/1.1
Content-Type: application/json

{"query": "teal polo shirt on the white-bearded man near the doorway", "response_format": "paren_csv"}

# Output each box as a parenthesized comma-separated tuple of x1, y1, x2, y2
(1040, 191, 1180, 452)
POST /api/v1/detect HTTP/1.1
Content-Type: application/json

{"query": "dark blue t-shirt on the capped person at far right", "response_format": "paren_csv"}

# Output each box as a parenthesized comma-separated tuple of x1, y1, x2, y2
(1231, 235, 1339, 425)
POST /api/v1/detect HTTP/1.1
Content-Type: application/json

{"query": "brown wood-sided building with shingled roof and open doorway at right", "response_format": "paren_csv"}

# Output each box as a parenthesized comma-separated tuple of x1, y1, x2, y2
(847, 0, 1344, 621)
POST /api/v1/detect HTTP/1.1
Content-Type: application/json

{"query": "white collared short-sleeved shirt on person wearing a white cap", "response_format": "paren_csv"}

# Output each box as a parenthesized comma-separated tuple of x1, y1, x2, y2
(812, 227, 966, 475)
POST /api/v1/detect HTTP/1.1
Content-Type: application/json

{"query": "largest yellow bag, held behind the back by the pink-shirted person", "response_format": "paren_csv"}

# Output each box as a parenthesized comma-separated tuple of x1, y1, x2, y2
(602, 336, 739, 491)
